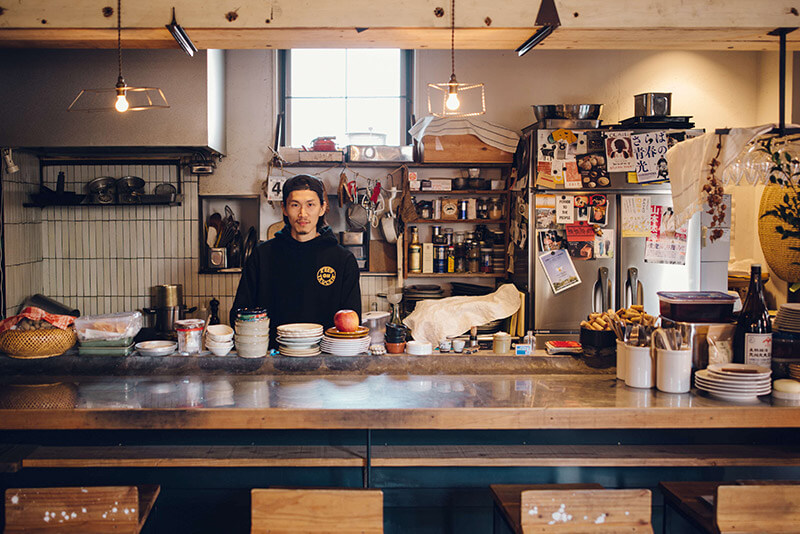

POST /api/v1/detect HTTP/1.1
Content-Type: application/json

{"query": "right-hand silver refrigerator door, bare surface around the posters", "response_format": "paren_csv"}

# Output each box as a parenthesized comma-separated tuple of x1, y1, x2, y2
(617, 194, 700, 315)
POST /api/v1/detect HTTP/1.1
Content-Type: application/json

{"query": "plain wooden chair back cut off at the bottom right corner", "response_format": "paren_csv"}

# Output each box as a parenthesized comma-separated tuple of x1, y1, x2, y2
(715, 484, 800, 534)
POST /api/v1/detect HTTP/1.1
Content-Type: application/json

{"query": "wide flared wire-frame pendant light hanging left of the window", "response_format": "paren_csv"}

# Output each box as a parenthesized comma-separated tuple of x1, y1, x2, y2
(67, 0, 169, 113)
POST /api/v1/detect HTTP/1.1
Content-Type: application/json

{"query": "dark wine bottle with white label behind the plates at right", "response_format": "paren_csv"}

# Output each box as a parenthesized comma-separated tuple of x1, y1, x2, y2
(733, 264, 772, 368)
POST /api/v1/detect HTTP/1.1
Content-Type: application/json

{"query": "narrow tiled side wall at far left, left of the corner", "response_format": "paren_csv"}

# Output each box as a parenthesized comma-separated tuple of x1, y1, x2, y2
(2, 152, 44, 316)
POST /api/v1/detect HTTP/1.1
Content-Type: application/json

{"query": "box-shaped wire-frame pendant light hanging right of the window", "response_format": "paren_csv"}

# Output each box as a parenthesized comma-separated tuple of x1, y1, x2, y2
(428, 0, 486, 118)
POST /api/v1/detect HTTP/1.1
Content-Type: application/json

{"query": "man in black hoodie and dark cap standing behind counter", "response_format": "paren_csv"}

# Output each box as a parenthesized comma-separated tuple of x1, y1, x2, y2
(231, 174, 361, 348)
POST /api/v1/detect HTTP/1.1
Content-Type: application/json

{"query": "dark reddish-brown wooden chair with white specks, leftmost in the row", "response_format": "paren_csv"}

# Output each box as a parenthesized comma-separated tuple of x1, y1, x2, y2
(5, 486, 161, 534)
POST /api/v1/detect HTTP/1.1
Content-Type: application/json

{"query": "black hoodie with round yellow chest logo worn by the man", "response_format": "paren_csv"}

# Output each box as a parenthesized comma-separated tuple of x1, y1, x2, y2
(230, 226, 361, 348)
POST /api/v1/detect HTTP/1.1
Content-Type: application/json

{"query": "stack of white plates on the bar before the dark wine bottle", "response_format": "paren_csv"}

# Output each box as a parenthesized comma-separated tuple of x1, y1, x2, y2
(694, 363, 772, 401)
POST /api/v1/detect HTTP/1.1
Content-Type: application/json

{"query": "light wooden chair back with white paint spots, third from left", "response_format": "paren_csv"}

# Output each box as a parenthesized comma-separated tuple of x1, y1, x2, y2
(521, 489, 653, 534)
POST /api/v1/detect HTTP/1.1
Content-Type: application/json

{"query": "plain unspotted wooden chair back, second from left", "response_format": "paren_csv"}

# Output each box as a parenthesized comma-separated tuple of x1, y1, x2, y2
(250, 488, 383, 534)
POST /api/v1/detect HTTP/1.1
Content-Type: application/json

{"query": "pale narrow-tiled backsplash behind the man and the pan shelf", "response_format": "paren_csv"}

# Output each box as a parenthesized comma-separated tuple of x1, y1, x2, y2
(3, 155, 395, 321)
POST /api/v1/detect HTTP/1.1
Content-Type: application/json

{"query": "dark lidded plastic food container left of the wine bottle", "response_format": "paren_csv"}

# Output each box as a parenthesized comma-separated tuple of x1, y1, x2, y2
(656, 291, 736, 323)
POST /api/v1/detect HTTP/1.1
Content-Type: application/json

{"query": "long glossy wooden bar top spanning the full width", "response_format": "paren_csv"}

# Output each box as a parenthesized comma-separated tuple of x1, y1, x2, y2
(0, 374, 800, 429)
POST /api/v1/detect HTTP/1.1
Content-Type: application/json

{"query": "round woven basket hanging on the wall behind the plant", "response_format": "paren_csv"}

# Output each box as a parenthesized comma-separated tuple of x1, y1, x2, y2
(758, 185, 800, 284)
